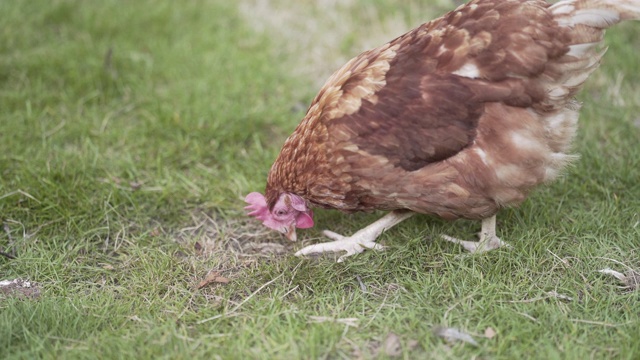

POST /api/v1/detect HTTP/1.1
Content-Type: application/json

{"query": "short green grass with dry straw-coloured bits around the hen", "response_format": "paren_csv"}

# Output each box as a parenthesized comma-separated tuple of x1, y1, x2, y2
(0, 0, 640, 359)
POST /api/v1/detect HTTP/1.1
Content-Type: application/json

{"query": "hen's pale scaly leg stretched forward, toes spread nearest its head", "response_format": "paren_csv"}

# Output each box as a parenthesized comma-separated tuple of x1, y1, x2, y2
(295, 210, 415, 262)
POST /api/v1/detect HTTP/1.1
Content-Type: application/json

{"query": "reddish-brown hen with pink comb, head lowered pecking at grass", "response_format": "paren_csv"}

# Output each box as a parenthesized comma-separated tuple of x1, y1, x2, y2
(245, 0, 640, 261)
